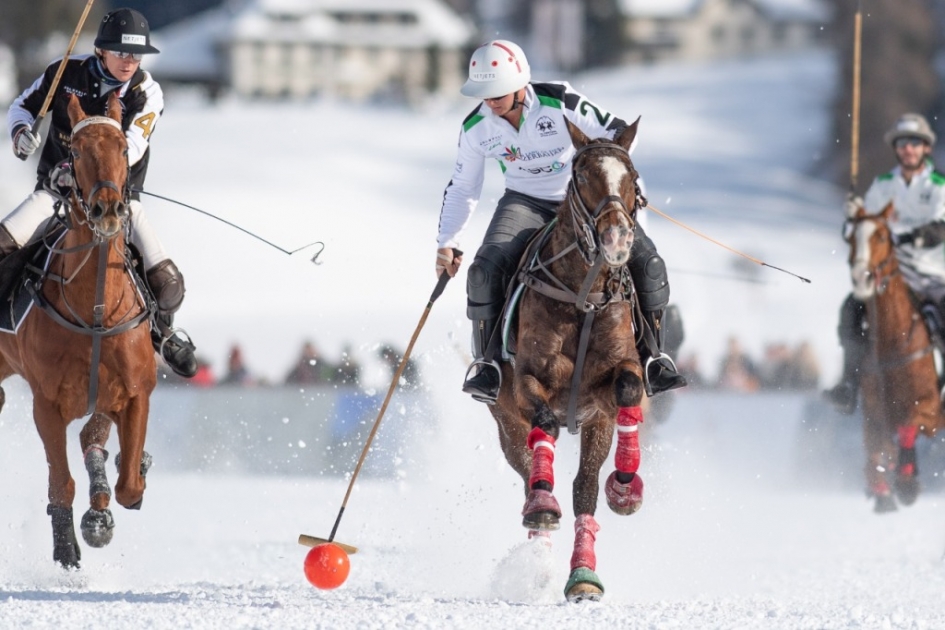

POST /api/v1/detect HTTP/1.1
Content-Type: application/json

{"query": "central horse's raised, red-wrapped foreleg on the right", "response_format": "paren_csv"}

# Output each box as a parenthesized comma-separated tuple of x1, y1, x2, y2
(604, 369, 643, 516)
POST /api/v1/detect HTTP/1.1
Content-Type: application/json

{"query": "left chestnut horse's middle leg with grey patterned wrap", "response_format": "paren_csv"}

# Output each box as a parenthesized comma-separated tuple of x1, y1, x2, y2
(79, 413, 115, 547)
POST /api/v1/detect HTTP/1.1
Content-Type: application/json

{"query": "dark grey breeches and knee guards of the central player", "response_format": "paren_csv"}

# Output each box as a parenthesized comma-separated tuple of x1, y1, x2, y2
(466, 191, 669, 321)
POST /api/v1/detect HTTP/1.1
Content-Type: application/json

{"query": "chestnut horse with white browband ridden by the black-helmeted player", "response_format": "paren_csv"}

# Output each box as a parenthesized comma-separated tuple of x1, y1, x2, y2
(0, 93, 157, 568)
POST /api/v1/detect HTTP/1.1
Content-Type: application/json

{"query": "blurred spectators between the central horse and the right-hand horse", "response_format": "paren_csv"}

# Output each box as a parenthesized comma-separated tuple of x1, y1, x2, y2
(676, 337, 820, 392)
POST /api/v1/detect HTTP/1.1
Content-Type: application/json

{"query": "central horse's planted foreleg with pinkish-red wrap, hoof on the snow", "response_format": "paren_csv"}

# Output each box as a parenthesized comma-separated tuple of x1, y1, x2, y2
(564, 421, 613, 602)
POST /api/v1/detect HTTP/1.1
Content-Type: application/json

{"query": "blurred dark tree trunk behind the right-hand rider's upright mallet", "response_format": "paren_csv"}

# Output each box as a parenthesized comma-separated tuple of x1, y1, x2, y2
(825, 0, 941, 193)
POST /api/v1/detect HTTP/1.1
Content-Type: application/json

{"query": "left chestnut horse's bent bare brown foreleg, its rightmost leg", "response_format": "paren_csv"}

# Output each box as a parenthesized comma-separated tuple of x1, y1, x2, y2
(115, 396, 151, 510)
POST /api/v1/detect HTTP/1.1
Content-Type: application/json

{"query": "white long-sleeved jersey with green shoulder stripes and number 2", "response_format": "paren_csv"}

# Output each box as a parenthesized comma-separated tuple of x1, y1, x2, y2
(437, 82, 633, 248)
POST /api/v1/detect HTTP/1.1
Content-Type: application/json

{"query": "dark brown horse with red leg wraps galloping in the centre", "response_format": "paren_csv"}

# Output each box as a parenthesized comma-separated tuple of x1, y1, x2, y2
(490, 119, 646, 601)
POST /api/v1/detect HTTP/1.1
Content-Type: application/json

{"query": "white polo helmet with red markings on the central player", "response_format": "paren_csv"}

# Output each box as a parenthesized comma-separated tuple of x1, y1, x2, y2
(459, 39, 532, 98)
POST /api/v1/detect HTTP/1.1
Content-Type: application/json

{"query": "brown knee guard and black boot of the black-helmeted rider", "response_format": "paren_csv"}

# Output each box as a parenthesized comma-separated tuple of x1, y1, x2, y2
(146, 258, 197, 378)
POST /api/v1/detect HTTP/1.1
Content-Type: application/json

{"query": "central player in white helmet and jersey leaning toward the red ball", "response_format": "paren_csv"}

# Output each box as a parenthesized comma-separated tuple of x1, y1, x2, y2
(437, 40, 686, 403)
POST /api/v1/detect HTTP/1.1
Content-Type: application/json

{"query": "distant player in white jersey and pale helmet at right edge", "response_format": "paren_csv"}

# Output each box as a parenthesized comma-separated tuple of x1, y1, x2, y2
(826, 114, 945, 413)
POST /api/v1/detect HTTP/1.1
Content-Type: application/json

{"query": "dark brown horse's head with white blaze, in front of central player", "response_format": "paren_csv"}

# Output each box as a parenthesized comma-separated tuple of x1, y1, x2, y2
(567, 118, 643, 267)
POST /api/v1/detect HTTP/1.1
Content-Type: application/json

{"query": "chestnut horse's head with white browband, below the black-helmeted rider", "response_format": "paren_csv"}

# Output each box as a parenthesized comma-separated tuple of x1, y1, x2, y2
(68, 92, 129, 239)
